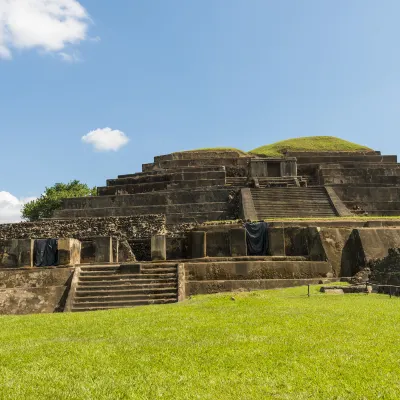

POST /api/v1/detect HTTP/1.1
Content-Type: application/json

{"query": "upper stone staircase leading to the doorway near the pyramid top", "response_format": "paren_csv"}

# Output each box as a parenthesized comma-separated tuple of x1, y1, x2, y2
(251, 187, 337, 219)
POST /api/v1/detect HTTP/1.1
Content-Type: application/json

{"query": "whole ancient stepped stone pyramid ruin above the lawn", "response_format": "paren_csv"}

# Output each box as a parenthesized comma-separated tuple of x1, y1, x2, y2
(0, 139, 400, 313)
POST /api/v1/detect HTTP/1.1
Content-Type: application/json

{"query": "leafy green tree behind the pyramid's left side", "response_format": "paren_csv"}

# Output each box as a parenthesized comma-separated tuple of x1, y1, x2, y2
(22, 180, 97, 221)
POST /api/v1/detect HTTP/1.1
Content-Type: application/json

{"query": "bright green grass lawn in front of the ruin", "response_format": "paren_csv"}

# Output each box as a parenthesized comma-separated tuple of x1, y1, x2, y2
(0, 287, 400, 400)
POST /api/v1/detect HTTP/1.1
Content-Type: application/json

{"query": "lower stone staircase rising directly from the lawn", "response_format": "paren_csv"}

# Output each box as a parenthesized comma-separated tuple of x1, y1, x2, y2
(71, 263, 178, 312)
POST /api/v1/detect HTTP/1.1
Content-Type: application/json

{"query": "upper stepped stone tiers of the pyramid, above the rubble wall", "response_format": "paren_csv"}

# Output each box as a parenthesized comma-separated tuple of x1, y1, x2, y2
(54, 150, 400, 224)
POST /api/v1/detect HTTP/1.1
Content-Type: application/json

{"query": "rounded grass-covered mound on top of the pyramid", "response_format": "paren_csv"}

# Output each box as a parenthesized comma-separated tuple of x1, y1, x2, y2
(250, 136, 373, 157)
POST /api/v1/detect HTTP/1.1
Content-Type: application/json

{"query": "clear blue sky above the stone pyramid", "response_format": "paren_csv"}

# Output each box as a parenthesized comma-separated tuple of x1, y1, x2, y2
(0, 0, 400, 221)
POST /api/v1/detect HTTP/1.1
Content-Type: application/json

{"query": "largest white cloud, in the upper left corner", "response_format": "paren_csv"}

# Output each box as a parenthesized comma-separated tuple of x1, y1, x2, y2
(0, 0, 90, 59)
